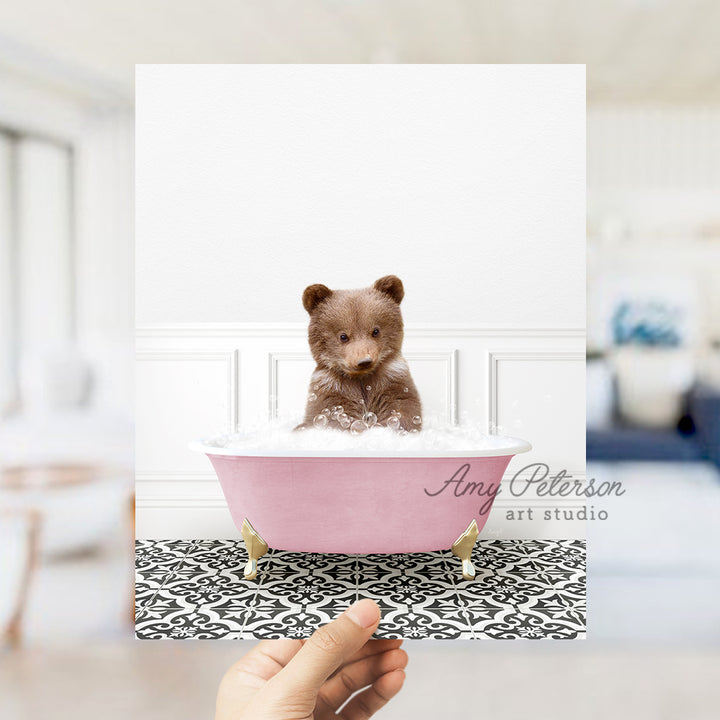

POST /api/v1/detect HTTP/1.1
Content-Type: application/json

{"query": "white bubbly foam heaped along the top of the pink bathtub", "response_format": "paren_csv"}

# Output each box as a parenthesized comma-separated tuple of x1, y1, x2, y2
(194, 419, 530, 457)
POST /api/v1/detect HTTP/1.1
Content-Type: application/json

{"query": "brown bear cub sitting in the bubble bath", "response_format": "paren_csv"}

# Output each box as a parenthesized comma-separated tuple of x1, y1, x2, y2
(295, 275, 422, 433)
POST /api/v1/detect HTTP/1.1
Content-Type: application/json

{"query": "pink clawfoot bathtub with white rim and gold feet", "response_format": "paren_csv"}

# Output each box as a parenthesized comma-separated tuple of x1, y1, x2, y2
(190, 437, 530, 579)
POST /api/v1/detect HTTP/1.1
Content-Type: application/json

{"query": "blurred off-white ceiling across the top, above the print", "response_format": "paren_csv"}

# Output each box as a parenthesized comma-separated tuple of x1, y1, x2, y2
(0, 0, 720, 103)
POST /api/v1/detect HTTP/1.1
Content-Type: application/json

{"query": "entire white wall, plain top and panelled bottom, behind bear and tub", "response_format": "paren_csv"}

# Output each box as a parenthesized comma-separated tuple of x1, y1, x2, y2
(136, 66, 585, 537)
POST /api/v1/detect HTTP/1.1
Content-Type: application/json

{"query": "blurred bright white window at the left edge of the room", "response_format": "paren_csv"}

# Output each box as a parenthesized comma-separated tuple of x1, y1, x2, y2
(0, 133, 75, 412)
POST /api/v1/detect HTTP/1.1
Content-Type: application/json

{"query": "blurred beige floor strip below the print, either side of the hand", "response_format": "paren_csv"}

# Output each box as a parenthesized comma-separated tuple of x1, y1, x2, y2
(0, 639, 720, 720)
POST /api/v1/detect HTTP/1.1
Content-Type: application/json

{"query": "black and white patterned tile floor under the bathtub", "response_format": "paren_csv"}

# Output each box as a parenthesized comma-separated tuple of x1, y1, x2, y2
(135, 540, 585, 640)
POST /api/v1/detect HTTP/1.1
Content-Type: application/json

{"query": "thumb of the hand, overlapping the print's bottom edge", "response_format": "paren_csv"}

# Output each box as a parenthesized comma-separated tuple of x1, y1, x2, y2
(274, 599, 380, 696)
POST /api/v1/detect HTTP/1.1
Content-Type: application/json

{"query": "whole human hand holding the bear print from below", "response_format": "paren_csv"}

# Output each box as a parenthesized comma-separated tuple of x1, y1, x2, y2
(215, 599, 407, 720)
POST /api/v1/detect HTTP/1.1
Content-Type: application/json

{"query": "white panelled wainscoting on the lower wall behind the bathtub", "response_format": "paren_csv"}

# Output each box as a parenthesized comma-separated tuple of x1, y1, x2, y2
(136, 323, 585, 539)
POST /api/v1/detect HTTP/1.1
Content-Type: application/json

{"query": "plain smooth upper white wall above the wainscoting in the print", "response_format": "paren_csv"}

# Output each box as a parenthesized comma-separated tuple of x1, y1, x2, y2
(136, 65, 585, 327)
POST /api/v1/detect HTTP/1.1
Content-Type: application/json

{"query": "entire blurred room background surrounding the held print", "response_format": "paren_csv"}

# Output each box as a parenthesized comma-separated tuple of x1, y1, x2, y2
(0, 0, 720, 720)
